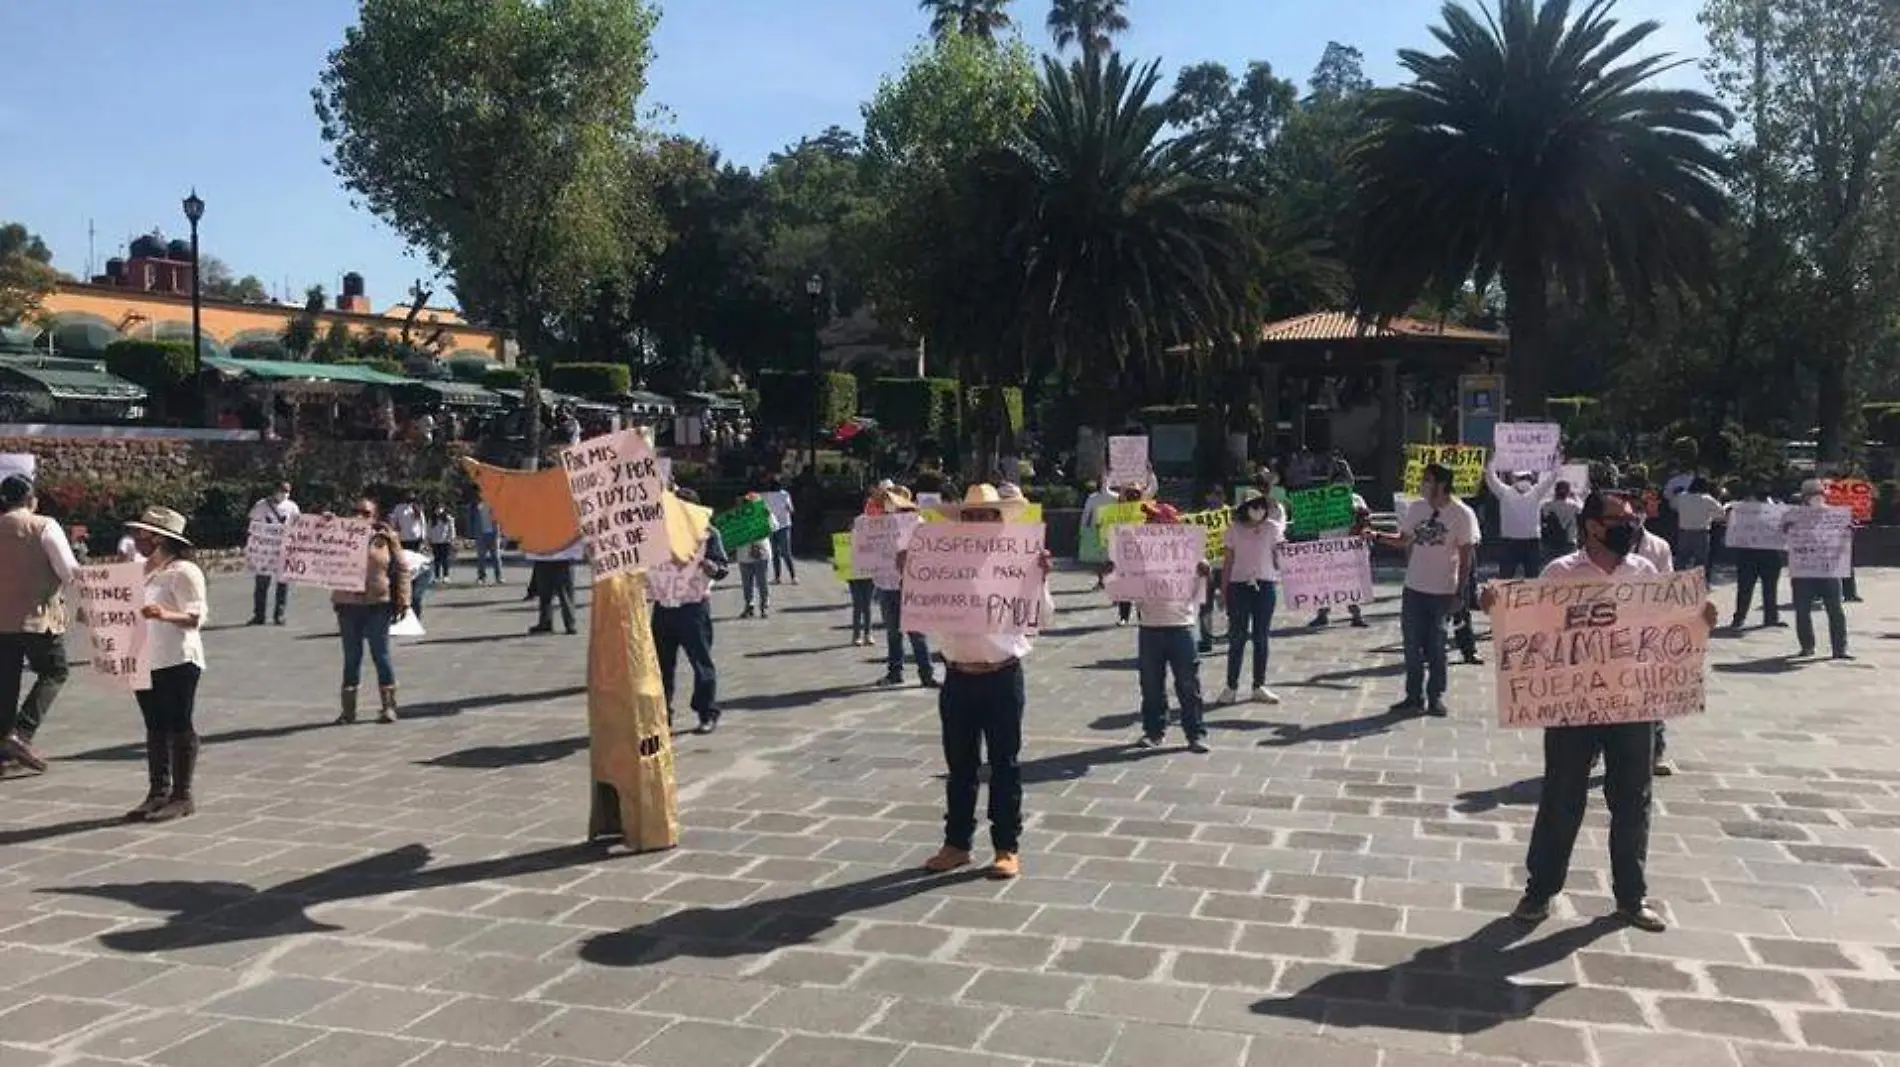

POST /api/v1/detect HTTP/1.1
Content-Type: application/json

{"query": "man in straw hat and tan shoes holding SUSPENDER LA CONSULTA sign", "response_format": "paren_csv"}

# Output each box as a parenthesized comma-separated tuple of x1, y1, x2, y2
(915, 482, 1056, 879)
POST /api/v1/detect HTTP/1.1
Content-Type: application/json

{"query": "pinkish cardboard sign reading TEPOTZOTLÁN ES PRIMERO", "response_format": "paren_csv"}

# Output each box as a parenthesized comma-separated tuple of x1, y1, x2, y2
(1492, 568, 1708, 729)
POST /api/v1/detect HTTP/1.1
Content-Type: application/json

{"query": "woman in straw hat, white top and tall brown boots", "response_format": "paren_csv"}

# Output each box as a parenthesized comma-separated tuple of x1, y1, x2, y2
(125, 507, 207, 822)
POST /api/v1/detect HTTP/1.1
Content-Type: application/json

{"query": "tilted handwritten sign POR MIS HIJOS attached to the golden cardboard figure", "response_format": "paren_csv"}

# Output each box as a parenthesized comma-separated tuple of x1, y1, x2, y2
(561, 427, 673, 581)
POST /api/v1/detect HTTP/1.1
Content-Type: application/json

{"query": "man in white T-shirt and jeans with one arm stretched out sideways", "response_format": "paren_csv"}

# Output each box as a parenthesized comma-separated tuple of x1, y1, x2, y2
(1366, 463, 1482, 718)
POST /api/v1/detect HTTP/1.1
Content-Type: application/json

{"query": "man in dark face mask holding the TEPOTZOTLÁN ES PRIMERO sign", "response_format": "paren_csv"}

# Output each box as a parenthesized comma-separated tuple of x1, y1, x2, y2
(1480, 492, 1716, 932)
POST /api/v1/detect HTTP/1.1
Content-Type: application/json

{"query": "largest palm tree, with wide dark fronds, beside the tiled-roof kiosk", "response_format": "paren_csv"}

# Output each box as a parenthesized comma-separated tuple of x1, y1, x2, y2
(1353, 0, 1729, 418)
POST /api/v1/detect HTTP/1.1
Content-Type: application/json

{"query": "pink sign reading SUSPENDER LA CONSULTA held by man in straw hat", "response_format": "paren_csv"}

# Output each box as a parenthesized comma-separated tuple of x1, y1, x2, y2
(899, 522, 1045, 634)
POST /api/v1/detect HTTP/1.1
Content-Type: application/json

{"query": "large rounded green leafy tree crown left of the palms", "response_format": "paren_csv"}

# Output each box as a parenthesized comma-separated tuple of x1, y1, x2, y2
(312, 0, 657, 355)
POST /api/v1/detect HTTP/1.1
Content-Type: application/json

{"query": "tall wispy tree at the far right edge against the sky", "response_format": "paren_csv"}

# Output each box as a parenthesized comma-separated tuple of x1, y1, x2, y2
(1702, 0, 1900, 461)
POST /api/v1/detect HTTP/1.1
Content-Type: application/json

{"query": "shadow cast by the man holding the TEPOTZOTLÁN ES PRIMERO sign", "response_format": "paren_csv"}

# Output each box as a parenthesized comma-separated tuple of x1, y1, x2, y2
(1252, 917, 1623, 1035)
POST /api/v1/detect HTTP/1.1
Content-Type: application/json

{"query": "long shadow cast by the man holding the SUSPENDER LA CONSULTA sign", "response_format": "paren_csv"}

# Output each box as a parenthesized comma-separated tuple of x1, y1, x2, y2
(581, 868, 982, 966)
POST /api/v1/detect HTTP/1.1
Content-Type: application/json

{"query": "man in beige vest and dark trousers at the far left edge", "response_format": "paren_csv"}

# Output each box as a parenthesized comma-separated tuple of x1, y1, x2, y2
(0, 475, 80, 771)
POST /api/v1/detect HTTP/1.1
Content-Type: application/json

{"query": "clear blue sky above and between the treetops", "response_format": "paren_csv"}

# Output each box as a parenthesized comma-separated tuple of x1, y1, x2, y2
(0, 0, 1704, 308)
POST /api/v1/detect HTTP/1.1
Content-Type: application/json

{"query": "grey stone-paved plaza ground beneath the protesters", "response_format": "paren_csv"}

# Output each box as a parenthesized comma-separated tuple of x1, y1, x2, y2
(0, 568, 1900, 1067)
